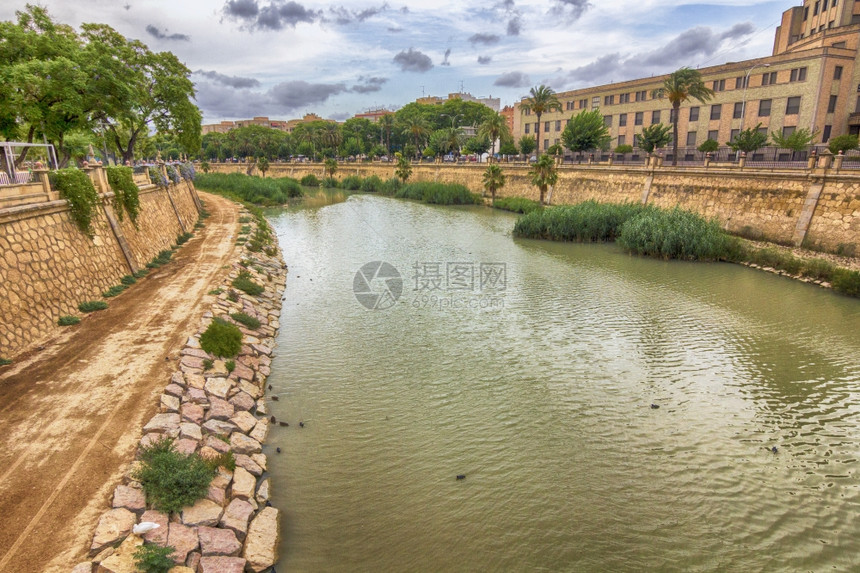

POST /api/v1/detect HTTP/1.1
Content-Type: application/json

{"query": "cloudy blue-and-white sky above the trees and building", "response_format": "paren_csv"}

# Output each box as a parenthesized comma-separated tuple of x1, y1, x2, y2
(0, 0, 792, 123)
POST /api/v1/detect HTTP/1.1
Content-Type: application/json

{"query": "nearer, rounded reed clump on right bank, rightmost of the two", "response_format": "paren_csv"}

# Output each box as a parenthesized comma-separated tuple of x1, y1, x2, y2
(618, 207, 738, 261)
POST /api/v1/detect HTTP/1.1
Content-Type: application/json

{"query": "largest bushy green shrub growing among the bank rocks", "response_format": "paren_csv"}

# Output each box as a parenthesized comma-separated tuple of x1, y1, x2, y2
(134, 438, 216, 513)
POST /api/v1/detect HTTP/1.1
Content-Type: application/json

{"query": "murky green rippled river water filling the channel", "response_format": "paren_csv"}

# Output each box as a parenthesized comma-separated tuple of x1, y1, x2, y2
(268, 196, 860, 571)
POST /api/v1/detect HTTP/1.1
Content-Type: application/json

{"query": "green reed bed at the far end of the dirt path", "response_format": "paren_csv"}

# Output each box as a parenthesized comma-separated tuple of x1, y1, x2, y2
(194, 173, 304, 207)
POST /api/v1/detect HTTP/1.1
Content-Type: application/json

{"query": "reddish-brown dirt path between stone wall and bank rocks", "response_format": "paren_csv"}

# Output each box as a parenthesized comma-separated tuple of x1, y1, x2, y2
(0, 194, 238, 572)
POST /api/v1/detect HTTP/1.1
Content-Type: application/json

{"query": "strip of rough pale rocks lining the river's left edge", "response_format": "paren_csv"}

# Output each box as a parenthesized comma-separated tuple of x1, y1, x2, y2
(73, 213, 287, 573)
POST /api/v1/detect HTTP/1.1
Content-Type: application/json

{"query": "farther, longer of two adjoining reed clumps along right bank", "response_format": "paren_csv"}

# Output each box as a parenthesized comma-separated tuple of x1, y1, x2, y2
(514, 201, 651, 243)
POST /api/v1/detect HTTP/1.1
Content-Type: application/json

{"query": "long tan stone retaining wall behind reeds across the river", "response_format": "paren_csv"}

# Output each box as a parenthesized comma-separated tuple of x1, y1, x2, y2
(213, 163, 860, 254)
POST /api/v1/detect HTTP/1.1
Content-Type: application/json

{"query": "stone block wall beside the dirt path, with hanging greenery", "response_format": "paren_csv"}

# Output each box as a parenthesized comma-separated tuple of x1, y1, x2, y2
(0, 163, 199, 358)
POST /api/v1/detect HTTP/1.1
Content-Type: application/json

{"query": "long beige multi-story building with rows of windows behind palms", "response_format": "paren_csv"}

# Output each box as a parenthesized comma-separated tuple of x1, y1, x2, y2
(514, 0, 860, 154)
